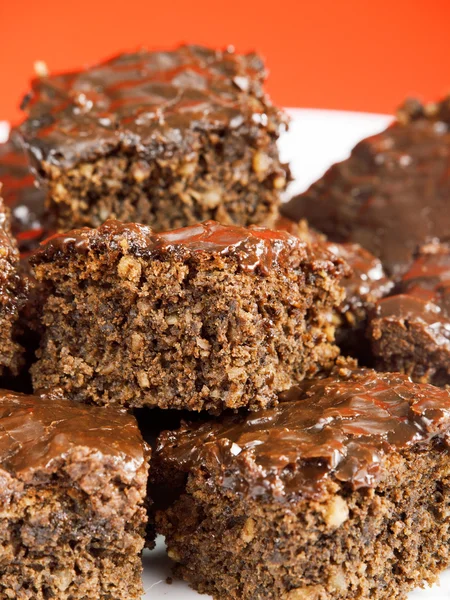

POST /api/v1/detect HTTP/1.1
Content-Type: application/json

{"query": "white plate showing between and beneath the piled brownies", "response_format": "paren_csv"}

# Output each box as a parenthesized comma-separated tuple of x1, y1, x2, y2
(0, 109, 450, 600)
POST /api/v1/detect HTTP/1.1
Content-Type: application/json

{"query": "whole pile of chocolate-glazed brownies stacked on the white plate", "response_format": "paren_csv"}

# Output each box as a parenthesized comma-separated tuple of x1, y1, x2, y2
(0, 46, 450, 600)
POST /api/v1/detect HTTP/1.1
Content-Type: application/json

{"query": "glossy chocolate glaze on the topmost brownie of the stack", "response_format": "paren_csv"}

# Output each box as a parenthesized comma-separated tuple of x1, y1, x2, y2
(22, 46, 284, 166)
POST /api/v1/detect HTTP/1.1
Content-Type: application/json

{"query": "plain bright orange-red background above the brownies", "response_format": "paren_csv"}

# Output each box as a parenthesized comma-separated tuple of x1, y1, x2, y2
(0, 0, 450, 120)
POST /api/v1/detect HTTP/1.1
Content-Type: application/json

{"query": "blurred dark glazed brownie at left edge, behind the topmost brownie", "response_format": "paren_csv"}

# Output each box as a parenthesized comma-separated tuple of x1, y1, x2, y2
(0, 129, 50, 256)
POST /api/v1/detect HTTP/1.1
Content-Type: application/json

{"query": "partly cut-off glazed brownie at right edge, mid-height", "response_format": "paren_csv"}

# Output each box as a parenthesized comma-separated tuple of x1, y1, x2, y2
(368, 244, 450, 385)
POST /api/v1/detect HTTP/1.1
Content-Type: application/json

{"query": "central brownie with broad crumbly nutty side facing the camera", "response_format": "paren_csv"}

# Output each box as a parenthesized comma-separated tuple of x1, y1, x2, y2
(31, 221, 347, 411)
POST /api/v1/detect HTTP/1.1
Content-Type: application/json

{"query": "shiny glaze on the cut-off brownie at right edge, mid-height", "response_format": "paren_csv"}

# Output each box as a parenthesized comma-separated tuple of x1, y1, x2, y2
(376, 244, 450, 350)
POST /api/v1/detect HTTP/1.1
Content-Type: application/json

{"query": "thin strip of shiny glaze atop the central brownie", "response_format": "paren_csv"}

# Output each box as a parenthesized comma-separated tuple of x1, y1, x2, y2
(30, 220, 346, 274)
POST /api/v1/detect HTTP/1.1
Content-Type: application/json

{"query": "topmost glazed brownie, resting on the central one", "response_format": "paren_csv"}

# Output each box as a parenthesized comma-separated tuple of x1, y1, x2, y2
(21, 46, 287, 231)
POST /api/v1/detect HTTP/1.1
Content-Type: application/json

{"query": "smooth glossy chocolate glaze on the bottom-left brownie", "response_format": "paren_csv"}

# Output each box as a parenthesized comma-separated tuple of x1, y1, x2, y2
(0, 390, 145, 480)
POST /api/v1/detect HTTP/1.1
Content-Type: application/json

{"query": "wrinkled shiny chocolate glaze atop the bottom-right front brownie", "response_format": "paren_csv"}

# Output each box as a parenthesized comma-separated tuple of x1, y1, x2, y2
(155, 369, 450, 502)
